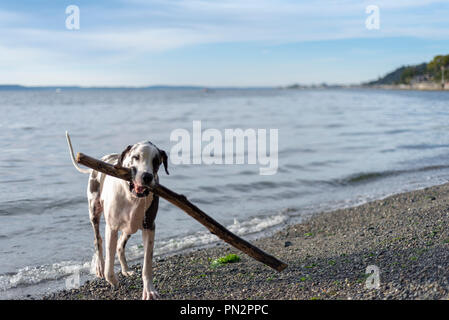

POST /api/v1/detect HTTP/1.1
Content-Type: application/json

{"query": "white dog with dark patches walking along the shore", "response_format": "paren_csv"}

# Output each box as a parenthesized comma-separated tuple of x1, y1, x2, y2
(66, 132, 169, 300)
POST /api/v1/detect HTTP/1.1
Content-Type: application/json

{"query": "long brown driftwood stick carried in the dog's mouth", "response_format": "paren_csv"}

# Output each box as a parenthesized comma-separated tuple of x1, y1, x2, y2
(76, 153, 287, 272)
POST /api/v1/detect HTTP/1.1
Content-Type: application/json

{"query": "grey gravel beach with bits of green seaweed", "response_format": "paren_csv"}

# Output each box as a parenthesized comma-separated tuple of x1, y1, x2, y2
(44, 184, 449, 300)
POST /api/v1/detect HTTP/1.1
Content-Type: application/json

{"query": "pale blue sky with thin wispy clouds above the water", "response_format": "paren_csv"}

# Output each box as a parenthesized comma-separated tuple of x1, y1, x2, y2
(0, 0, 449, 86)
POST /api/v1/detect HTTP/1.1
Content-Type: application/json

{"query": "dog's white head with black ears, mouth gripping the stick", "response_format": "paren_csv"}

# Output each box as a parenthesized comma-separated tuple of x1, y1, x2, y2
(118, 141, 169, 198)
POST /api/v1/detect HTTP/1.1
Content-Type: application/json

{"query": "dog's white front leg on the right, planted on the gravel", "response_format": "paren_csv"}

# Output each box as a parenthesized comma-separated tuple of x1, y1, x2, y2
(142, 224, 159, 300)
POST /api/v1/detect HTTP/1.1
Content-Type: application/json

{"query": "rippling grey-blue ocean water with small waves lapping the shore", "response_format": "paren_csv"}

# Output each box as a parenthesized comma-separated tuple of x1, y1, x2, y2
(0, 89, 449, 299)
